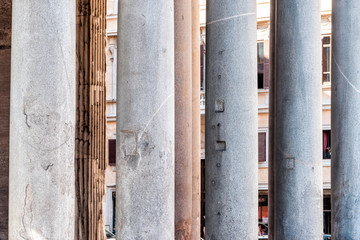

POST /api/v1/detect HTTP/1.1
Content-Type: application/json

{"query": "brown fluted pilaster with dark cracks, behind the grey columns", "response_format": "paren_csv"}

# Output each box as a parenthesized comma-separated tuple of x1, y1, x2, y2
(75, 0, 106, 240)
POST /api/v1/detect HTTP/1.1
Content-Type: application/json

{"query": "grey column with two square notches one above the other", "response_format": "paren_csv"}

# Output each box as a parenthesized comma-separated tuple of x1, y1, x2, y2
(205, 0, 258, 240)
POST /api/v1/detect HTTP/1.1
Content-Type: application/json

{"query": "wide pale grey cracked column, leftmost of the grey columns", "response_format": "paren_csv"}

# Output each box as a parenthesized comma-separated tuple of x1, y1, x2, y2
(9, 0, 75, 240)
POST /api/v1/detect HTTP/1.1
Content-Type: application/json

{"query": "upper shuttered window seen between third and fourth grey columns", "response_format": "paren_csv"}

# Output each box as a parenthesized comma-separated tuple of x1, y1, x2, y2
(257, 41, 270, 89)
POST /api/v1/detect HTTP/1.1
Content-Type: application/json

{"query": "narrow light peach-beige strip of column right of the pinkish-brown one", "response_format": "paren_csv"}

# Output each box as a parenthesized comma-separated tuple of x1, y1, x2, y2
(191, 0, 201, 240)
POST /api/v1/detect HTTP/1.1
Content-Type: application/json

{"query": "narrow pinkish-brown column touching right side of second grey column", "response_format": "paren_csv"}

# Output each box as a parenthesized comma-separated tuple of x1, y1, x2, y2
(174, 0, 192, 240)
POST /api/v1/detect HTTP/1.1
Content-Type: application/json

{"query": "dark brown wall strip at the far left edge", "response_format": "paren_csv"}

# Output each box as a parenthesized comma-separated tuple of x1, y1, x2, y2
(0, 0, 11, 240)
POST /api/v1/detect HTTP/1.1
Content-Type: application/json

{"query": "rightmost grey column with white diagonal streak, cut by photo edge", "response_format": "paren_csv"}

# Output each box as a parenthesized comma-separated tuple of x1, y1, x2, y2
(331, 0, 360, 240)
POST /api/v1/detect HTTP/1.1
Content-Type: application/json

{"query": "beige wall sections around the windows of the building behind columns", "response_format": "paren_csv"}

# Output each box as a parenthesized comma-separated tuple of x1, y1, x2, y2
(102, 0, 331, 191)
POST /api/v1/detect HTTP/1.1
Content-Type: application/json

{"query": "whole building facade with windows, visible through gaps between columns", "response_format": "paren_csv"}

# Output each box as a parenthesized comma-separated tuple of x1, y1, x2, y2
(104, 0, 331, 234)
